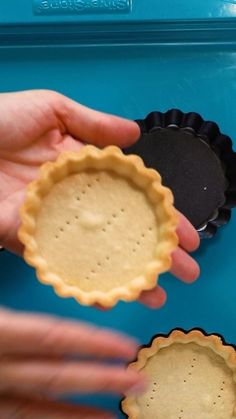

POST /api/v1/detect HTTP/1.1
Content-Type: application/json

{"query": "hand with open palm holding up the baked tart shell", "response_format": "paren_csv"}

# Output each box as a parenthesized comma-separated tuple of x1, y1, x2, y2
(0, 90, 199, 308)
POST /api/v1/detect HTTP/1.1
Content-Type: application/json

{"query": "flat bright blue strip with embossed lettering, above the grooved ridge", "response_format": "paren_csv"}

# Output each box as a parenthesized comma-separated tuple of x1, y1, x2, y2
(0, 0, 236, 23)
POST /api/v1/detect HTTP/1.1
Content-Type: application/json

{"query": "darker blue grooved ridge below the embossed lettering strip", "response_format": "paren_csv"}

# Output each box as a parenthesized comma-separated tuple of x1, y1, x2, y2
(0, 18, 236, 48)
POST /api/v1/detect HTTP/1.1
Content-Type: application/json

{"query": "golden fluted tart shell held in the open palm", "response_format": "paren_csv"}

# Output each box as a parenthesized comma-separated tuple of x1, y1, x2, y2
(19, 146, 178, 307)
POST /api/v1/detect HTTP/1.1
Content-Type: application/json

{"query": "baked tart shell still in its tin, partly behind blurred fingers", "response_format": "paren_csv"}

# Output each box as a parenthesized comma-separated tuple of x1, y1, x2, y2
(122, 330, 236, 419)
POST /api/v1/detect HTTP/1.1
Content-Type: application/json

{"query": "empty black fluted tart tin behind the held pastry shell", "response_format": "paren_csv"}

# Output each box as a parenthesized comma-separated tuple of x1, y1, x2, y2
(123, 109, 236, 238)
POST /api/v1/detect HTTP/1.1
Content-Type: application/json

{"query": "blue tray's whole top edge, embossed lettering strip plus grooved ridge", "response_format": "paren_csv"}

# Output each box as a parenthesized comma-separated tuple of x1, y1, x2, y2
(0, 0, 236, 47)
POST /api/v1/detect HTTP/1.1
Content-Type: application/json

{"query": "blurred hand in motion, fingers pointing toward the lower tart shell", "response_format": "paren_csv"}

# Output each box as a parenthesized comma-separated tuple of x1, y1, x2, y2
(0, 310, 145, 419)
